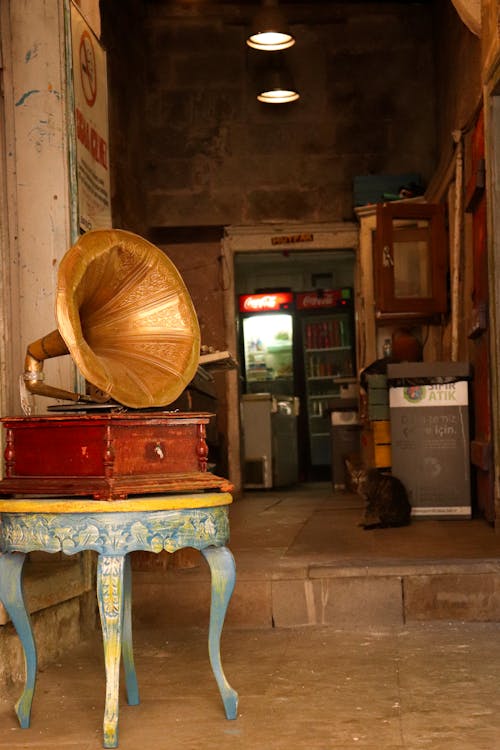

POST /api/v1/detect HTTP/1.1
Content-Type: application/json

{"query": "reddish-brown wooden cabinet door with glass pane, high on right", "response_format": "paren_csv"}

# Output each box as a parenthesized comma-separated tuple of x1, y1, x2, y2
(374, 201, 448, 318)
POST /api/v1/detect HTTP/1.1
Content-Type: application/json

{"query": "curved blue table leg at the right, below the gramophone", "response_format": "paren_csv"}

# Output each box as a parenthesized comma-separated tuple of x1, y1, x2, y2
(202, 547, 238, 719)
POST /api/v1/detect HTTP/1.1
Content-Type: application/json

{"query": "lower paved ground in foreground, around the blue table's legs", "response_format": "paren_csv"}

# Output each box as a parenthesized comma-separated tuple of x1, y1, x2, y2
(0, 623, 500, 750)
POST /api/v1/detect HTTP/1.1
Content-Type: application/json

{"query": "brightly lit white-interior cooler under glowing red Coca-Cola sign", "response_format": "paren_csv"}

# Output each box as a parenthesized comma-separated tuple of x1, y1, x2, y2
(239, 292, 294, 396)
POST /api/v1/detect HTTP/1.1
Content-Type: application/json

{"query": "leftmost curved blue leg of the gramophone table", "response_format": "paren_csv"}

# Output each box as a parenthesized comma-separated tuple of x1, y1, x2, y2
(0, 552, 37, 729)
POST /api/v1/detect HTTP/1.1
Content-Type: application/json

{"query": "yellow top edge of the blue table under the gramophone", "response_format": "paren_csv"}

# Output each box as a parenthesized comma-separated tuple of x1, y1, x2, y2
(0, 492, 233, 513)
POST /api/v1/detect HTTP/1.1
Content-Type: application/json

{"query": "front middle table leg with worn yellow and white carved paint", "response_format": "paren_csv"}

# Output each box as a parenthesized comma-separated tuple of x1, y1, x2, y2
(97, 555, 125, 747)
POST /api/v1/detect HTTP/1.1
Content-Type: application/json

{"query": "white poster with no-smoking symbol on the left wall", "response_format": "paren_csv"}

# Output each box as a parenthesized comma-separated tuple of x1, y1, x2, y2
(71, 4, 112, 232)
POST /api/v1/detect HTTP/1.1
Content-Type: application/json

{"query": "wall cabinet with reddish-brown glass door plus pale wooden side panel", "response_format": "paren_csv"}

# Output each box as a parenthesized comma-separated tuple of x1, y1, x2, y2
(356, 199, 449, 370)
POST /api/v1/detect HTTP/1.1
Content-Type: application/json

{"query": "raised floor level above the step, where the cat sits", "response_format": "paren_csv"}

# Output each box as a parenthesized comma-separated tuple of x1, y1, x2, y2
(230, 483, 500, 566)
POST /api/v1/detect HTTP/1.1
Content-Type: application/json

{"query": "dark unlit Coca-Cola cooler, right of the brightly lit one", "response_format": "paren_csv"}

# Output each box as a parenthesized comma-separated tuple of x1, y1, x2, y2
(296, 288, 355, 478)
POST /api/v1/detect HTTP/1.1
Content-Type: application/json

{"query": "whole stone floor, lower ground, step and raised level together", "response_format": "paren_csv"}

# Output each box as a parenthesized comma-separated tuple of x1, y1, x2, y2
(0, 485, 500, 750)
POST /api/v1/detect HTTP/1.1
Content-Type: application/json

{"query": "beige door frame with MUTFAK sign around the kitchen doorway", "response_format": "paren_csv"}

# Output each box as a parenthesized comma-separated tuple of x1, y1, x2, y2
(222, 221, 359, 495)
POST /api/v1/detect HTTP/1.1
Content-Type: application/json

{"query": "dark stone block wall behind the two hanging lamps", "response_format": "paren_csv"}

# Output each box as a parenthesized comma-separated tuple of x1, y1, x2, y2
(102, 0, 435, 227)
